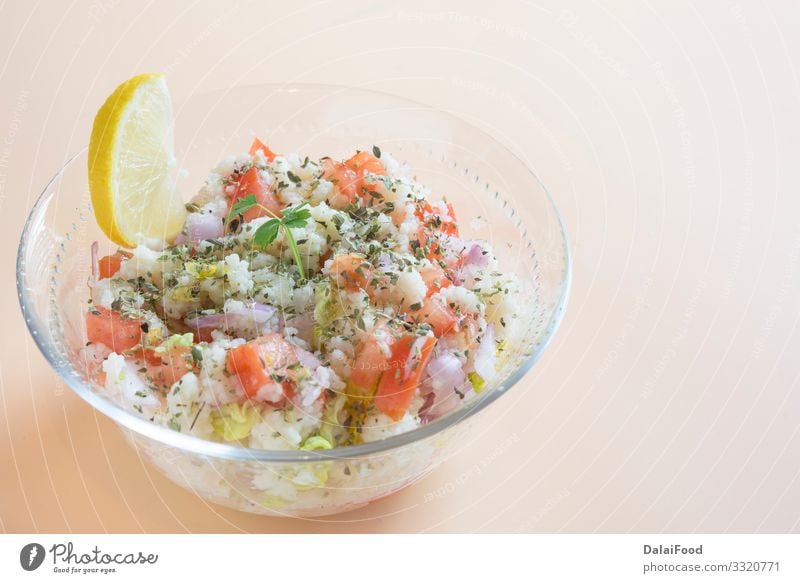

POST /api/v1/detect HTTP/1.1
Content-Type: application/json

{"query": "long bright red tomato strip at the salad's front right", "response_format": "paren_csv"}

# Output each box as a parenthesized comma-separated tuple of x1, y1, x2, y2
(374, 334, 436, 421)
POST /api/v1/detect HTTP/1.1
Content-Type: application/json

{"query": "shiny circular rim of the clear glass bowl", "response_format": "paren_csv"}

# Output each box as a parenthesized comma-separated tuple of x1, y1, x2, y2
(16, 83, 572, 463)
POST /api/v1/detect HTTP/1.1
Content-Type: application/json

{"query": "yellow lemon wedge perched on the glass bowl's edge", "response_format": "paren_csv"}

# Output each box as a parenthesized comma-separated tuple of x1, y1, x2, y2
(89, 73, 186, 247)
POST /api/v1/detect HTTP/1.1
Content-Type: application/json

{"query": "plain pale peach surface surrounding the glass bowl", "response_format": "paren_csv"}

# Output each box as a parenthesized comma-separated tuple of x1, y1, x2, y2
(0, 0, 800, 532)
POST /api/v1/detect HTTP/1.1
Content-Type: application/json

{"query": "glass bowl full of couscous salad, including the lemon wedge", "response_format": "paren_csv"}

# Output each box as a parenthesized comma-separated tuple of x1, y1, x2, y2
(18, 75, 569, 516)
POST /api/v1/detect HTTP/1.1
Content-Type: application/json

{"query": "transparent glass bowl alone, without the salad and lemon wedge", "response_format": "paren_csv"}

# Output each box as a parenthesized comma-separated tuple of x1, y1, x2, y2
(17, 84, 570, 517)
